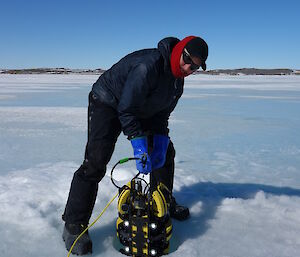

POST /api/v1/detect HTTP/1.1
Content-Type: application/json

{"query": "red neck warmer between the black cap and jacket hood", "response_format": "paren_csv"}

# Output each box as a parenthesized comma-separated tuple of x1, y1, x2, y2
(171, 36, 195, 78)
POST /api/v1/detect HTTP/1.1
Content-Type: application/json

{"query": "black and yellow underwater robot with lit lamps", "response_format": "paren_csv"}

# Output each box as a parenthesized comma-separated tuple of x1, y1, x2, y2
(116, 178, 172, 257)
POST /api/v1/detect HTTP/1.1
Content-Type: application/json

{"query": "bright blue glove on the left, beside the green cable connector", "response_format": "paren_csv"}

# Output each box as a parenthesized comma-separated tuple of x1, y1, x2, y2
(130, 137, 152, 174)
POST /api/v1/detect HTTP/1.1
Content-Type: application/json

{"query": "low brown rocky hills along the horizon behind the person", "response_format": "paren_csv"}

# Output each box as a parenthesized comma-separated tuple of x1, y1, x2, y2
(0, 68, 300, 75)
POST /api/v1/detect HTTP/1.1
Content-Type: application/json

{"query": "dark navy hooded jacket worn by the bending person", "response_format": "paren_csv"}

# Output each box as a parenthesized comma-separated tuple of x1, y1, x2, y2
(92, 37, 184, 138)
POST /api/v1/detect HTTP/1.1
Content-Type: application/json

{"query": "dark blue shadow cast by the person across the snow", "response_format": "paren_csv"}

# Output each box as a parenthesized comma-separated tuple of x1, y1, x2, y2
(92, 182, 300, 256)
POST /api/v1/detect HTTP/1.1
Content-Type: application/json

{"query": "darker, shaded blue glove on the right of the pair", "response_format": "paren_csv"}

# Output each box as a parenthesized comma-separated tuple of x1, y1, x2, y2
(150, 135, 170, 170)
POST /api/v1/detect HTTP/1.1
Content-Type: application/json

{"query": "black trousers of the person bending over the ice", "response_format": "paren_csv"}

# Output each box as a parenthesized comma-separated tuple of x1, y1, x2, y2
(63, 93, 175, 224)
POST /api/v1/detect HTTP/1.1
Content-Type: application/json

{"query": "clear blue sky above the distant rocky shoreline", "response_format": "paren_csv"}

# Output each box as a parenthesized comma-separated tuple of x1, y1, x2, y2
(0, 0, 300, 69)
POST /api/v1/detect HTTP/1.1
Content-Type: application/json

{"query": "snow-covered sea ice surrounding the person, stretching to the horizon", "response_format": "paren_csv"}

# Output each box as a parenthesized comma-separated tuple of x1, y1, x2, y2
(0, 74, 300, 257)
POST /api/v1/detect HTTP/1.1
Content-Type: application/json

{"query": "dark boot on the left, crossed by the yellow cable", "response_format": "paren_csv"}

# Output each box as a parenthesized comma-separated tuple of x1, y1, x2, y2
(63, 223, 92, 255)
